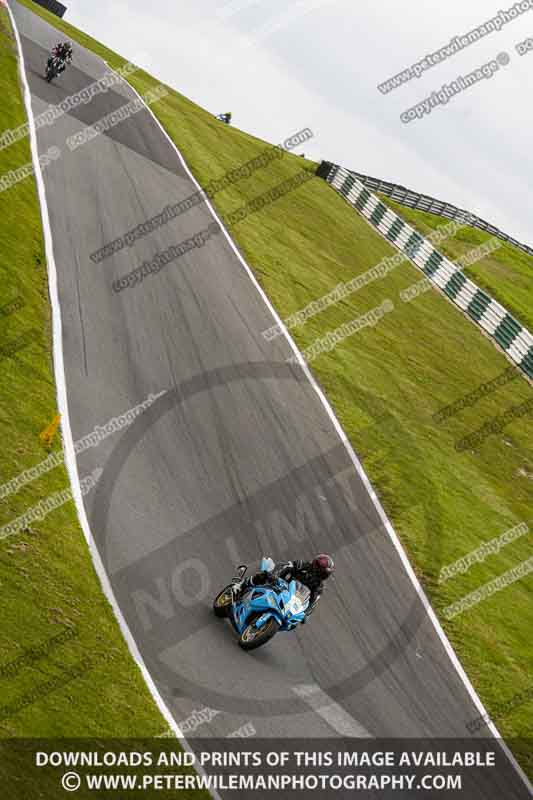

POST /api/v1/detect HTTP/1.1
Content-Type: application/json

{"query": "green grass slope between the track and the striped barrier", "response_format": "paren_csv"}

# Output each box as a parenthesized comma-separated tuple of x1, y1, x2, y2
(5, 0, 533, 775)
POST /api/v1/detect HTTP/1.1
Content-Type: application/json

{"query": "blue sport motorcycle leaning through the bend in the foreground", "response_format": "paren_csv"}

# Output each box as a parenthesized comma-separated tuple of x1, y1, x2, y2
(213, 558, 311, 650)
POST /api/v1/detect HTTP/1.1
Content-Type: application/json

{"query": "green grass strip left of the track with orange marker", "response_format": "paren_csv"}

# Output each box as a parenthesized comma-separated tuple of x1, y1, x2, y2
(0, 9, 209, 797)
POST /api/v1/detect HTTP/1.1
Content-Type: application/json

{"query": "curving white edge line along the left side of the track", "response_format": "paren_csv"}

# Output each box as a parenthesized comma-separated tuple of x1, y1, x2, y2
(7, 5, 221, 800)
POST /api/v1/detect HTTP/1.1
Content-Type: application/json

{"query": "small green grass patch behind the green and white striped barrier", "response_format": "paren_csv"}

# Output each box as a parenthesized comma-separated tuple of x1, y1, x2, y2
(380, 194, 533, 331)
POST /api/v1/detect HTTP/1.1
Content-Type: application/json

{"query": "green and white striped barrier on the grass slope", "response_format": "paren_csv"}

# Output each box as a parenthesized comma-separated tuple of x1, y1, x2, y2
(317, 162, 533, 378)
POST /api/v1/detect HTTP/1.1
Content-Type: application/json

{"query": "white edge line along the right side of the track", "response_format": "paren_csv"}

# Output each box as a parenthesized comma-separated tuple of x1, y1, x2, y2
(117, 70, 533, 792)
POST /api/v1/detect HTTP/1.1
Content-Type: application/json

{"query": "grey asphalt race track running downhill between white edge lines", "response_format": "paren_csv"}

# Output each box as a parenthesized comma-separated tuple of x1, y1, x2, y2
(10, 1, 527, 798)
